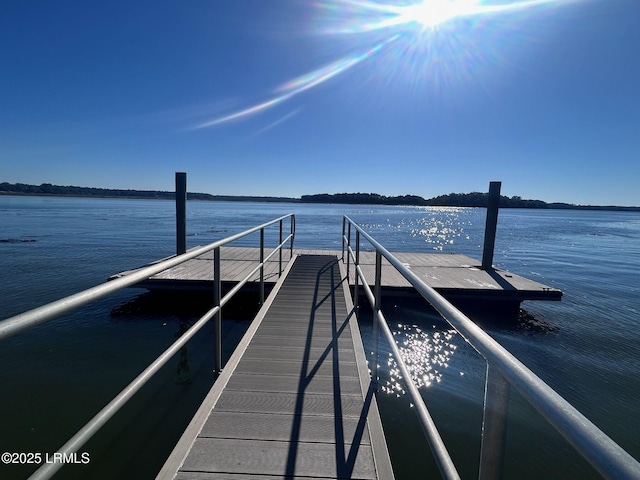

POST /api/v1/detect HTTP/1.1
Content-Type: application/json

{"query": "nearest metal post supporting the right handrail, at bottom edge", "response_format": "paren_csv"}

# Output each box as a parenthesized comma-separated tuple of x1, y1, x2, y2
(478, 363, 509, 480)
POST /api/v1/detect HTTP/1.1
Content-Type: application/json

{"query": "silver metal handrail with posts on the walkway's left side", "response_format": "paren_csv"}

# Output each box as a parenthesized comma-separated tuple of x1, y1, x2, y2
(0, 213, 295, 479)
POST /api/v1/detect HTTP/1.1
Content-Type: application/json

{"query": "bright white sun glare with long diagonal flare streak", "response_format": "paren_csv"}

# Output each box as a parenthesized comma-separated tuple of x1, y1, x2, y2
(192, 0, 582, 129)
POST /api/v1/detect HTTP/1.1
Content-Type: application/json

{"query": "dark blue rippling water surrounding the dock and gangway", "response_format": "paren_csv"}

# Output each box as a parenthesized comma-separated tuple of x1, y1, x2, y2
(0, 196, 640, 479)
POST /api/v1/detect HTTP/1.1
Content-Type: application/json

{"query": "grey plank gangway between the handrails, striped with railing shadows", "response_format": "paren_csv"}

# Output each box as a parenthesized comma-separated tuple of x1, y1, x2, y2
(158, 254, 393, 480)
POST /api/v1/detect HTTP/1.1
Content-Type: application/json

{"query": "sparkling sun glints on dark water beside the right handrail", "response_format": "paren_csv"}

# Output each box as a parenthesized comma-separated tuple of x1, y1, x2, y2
(380, 323, 464, 397)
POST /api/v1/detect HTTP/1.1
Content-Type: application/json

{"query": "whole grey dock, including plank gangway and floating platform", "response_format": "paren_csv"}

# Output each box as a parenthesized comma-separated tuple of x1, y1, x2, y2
(126, 246, 562, 480)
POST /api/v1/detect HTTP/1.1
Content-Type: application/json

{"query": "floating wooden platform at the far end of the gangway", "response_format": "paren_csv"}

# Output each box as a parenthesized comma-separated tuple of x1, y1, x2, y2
(116, 247, 562, 303)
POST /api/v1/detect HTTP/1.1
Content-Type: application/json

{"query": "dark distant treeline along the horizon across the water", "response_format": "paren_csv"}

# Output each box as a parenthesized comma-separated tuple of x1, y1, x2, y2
(0, 182, 640, 212)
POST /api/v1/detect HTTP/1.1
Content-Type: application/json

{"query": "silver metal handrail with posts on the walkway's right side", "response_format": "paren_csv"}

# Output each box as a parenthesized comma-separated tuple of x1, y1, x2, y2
(342, 215, 640, 480)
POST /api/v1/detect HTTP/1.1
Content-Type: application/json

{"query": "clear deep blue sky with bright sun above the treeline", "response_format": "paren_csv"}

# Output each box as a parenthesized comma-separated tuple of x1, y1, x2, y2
(0, 0, 640, 205)
